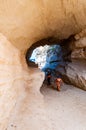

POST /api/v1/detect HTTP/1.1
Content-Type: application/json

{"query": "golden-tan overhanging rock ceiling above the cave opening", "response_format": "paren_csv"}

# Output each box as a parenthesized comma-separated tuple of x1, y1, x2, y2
(0, 0, 86, 50)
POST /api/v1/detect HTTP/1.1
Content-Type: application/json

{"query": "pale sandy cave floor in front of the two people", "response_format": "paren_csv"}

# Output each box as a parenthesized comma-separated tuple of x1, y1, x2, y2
(41, 84, 86, 130)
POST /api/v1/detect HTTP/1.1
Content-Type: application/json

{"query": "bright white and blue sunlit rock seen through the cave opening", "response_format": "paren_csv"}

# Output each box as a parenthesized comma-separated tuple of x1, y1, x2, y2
(28, 44, 63, 72)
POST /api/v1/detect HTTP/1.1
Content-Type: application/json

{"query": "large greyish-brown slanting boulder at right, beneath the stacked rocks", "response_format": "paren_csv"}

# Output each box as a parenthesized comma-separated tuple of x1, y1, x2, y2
(61, 60, 86, 90)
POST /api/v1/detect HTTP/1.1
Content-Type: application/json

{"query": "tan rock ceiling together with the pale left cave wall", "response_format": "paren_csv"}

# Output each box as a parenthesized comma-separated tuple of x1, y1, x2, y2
(0, 0, 86, 130)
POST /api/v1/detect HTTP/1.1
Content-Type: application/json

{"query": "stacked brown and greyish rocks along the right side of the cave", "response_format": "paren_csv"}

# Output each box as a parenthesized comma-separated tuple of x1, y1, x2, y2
(60, 33, 86, 90)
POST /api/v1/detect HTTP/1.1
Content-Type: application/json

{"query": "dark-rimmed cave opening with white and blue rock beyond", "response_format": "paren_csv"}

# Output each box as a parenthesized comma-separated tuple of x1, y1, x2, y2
(26, 38, 71, 89)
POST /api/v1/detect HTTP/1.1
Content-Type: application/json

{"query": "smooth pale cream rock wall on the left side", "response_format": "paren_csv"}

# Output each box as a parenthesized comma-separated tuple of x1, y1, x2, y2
(0, 34, 51, 130)
